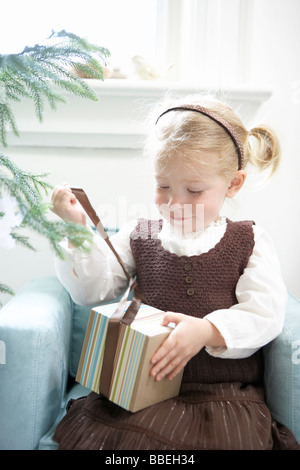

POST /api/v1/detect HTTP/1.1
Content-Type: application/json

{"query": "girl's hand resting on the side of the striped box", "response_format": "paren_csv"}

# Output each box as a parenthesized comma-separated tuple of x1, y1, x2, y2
(151, 312, 226, 381)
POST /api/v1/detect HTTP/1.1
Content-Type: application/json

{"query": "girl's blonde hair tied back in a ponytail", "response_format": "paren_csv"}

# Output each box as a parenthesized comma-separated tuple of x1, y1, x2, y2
(147, 96, 280, 179)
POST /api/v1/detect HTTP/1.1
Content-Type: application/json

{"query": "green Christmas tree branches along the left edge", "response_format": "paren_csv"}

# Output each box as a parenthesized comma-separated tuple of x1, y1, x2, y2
(0, 31, 109, 302)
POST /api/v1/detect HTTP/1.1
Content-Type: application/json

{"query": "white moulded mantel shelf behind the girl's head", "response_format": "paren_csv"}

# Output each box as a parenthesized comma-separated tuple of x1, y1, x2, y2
(8, 79, 272, 149)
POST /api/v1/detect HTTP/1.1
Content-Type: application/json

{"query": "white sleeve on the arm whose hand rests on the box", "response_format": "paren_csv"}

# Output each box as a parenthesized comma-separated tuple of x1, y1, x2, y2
(206, 226, 287, 358)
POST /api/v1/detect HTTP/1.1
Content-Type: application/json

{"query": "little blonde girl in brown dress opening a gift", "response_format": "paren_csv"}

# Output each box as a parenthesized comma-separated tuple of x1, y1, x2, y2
(52, 93, 299, 450)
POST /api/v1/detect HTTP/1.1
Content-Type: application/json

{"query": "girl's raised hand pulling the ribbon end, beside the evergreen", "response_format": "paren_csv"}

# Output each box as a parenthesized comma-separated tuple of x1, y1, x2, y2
(51, 184, 86, 225)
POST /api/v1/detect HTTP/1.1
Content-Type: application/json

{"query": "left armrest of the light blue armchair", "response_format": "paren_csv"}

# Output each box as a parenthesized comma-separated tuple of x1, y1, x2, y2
(0, 277, 73, 449)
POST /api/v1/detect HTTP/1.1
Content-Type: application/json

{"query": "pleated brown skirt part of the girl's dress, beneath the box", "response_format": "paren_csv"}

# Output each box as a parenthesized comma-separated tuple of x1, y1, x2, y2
(54, 383, 300, 450)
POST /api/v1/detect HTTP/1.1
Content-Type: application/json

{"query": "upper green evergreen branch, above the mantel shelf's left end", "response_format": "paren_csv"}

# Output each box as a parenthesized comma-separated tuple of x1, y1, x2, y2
(0, 30, 110, 147)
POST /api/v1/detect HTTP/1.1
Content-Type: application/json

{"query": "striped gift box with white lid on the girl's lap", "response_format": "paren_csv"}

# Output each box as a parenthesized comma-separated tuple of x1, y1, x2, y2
(76, 303, 182, 412)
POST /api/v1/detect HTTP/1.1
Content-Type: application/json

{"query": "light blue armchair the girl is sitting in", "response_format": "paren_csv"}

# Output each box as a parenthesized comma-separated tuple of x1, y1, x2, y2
(0, 277, 300, 449)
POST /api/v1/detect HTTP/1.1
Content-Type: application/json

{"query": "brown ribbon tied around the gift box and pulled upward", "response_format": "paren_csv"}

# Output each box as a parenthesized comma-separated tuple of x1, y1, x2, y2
(71, 188, 142, 397)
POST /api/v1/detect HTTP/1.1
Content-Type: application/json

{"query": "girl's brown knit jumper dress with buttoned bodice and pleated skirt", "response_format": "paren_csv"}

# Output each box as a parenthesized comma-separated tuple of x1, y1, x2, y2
(54, 220, 299, 450)
